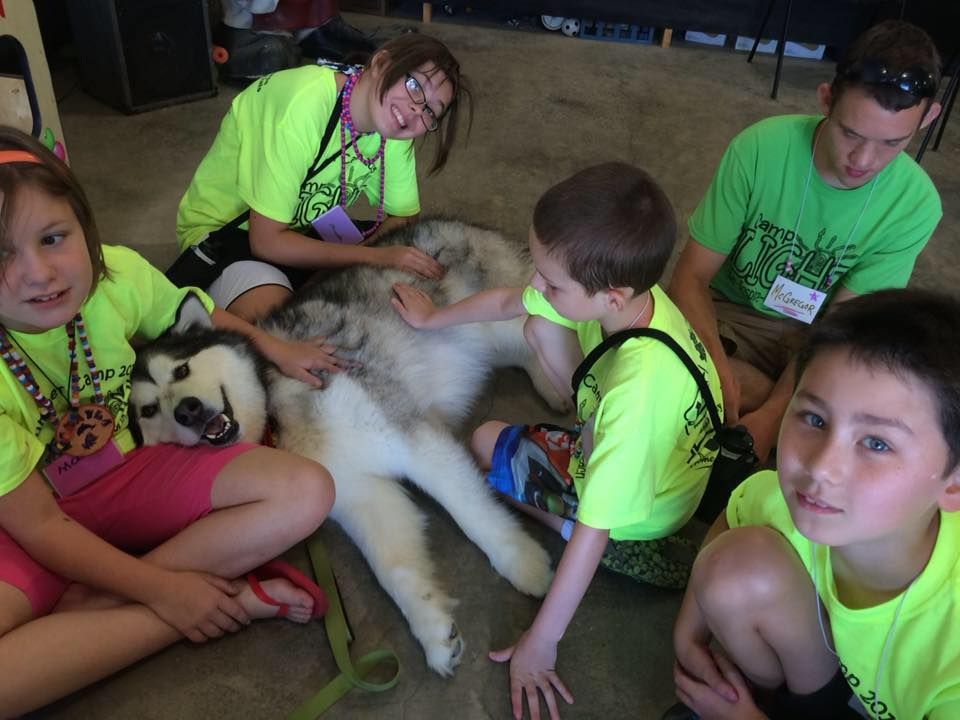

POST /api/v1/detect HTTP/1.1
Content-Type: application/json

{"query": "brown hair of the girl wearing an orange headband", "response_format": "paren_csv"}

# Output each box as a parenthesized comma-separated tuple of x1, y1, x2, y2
(0, 125, 106, 292)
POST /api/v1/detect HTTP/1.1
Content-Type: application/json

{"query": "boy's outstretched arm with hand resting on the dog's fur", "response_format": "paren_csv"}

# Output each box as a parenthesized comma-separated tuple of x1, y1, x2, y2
(390, 283, 527, 330)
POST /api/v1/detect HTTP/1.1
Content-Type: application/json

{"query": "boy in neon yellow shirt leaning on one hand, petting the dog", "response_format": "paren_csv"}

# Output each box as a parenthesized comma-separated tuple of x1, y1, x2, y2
(394, 163, 720, 718)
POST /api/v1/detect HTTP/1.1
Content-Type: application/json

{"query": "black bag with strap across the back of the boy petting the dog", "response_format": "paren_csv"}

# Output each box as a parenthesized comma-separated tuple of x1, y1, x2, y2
(572, 328, 757, 523)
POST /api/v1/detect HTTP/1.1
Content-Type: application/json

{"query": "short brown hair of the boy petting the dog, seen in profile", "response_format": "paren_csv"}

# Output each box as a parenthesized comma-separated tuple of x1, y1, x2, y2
(533, 162, 677, 295)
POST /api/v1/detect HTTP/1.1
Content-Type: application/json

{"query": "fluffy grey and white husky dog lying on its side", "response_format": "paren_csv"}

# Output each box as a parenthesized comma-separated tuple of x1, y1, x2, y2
(130, 220, 565, 675)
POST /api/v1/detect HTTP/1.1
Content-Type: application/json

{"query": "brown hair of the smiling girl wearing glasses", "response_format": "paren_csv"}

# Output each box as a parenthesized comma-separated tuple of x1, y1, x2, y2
(371, 33, 473, 175)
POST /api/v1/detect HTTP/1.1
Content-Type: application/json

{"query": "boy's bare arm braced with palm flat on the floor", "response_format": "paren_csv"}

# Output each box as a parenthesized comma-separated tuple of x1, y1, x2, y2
(490, 521, 610, 720)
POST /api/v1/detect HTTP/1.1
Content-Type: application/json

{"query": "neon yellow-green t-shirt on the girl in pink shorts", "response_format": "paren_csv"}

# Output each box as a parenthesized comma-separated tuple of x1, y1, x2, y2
(0, 245, 213, 495)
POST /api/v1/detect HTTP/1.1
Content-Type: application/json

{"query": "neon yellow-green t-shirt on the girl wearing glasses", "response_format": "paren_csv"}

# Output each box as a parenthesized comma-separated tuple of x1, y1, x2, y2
(177, 65, 420, 250)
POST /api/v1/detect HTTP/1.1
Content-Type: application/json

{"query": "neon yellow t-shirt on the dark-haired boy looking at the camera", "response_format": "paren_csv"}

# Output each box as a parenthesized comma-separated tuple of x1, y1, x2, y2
(727, 470, 960, 720)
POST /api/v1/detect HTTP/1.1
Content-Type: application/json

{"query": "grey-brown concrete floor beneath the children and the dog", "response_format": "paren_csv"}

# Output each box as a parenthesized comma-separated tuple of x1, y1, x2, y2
(33, 15, 960, 720)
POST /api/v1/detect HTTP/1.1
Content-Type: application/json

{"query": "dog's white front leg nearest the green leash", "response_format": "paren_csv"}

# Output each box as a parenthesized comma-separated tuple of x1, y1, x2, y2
(331, 469, 464, 676)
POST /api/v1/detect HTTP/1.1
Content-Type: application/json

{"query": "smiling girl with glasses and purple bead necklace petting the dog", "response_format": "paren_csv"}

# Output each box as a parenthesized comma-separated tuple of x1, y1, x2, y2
(167, 34, 470, 320)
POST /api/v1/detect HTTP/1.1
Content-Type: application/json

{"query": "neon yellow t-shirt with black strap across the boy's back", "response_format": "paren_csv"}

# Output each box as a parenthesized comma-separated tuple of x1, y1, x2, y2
(523, 285, 723, 540)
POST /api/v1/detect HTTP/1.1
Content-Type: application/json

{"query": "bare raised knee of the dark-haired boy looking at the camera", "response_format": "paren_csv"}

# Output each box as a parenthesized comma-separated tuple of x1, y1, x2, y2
(690, 527, 810, 618)
